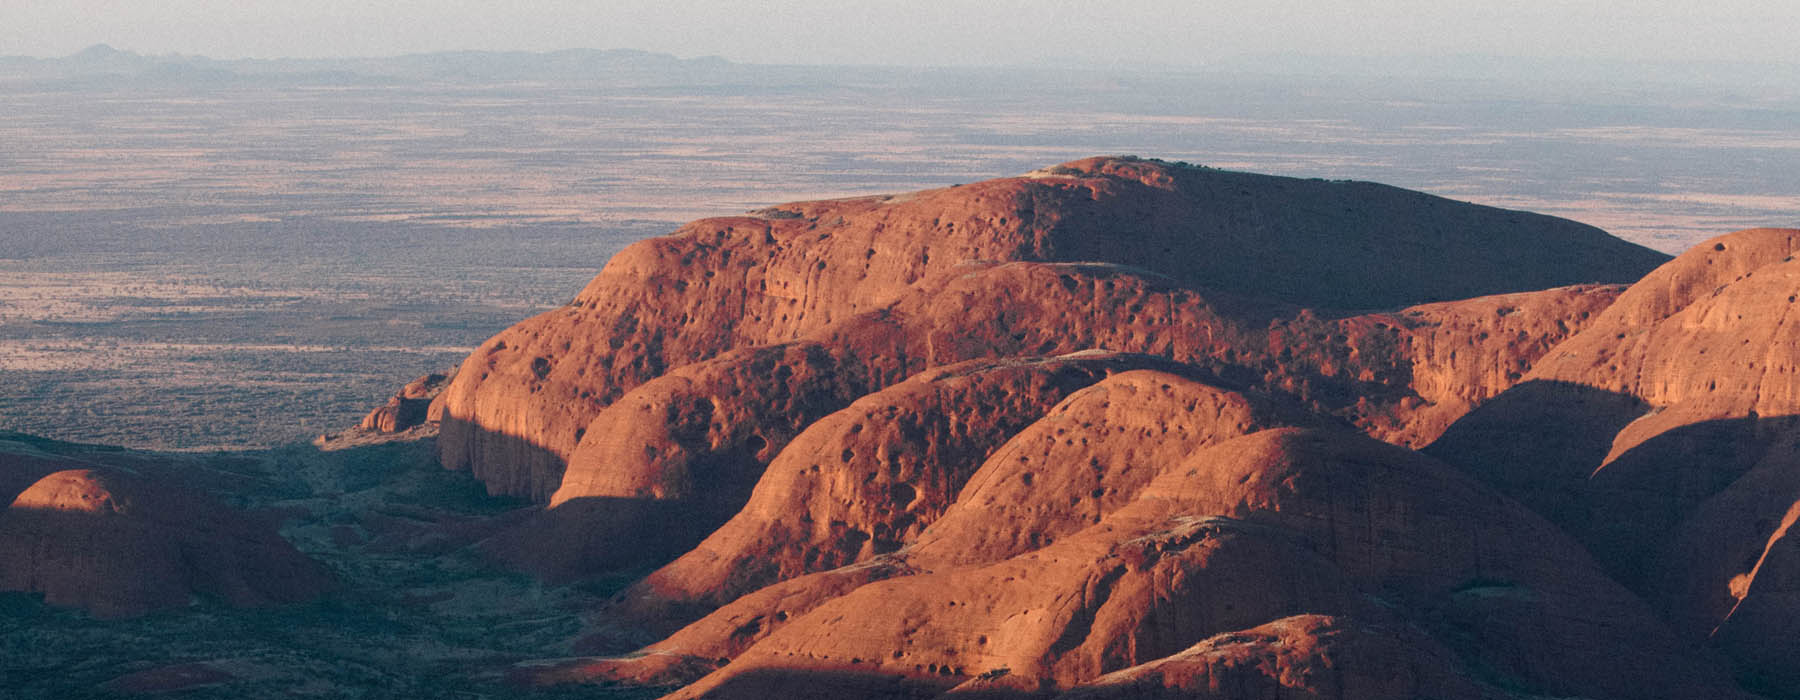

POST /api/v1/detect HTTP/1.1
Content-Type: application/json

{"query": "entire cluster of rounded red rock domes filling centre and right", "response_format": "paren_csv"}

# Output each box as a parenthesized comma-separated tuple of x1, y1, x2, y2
(397, 158, 1800, 698)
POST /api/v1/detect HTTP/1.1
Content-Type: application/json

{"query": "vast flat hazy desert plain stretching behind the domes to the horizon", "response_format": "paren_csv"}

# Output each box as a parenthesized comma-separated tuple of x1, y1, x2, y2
(0, 50, 1800, 448)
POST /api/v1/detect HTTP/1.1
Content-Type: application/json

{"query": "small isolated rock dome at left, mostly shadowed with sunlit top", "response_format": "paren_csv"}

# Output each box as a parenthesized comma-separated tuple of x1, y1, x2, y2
(0, 470, 331, 617)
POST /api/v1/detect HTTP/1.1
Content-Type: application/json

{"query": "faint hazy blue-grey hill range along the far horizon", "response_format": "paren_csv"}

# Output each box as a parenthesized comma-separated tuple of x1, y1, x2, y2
(0, 43, 1795, 95)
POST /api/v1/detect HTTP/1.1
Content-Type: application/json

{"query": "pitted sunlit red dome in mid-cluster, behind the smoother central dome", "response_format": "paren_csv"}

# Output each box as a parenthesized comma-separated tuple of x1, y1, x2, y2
(612, 353, 1172, 619)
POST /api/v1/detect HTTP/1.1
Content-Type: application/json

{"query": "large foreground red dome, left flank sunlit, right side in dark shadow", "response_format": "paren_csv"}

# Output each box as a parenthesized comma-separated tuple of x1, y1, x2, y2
(653, 430, 1735, 698)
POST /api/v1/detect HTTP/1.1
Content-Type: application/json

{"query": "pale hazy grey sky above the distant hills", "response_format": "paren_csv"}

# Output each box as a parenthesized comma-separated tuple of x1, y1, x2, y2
(0, 0, 1800, 65)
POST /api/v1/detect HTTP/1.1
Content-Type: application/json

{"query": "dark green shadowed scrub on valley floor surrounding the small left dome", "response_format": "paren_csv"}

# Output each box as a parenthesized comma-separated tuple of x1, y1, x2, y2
(0, 432, 657, 700)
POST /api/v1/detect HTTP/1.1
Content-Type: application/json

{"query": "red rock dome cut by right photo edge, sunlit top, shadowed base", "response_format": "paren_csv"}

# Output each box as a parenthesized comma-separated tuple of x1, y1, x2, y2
(1427, 229, 1800, 696)
